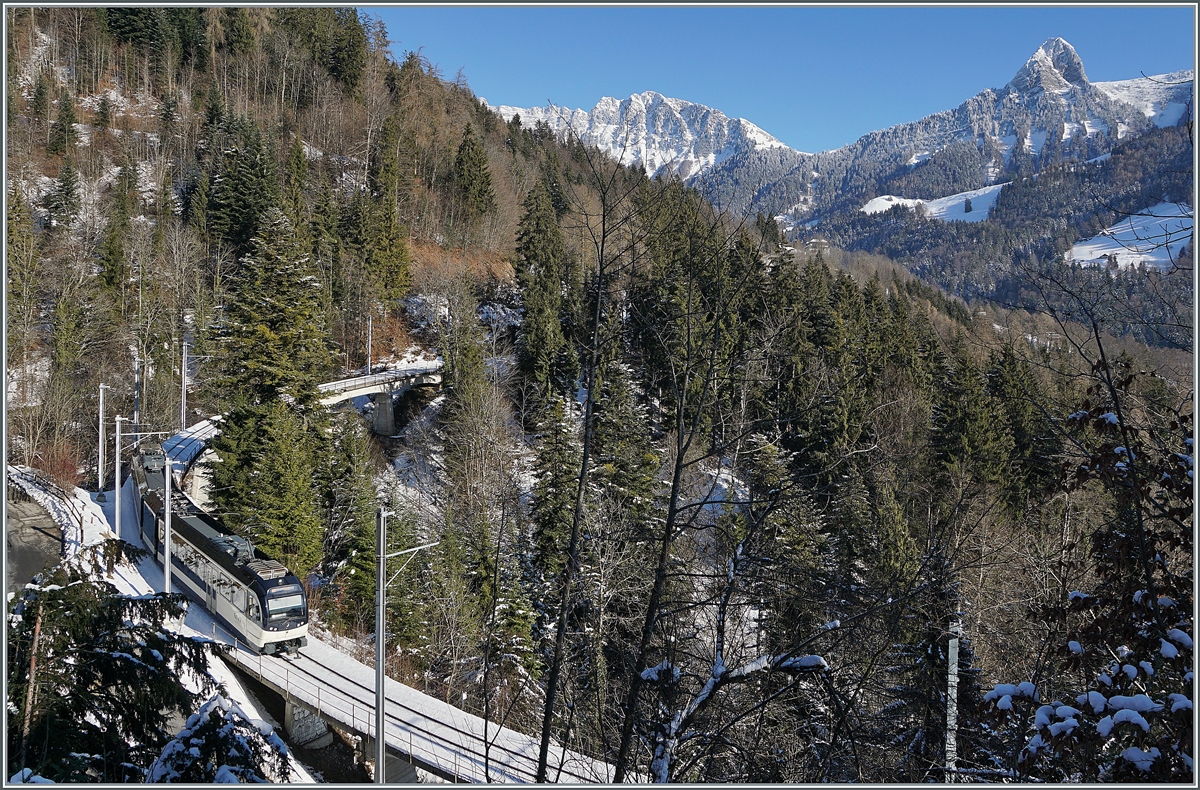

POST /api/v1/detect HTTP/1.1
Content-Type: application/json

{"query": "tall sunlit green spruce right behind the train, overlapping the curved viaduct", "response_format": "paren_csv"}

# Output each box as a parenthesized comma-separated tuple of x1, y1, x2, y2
(208, 209, 332, 559)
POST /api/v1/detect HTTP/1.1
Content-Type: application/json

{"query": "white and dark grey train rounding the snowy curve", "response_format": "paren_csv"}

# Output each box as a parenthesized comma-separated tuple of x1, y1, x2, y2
(132, 445, 308, 654)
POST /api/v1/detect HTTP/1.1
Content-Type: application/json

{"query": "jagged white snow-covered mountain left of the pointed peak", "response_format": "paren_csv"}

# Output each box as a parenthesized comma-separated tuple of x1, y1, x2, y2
(494, 90, 787, 179)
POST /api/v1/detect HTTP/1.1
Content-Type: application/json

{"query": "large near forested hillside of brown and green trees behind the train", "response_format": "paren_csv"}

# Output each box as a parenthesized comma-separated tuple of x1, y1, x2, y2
(6, 7, 1194, 783)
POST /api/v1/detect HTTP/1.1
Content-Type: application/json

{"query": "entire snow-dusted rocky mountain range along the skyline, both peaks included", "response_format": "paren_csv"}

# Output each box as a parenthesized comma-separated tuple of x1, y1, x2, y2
(496, 38, 1193, 222)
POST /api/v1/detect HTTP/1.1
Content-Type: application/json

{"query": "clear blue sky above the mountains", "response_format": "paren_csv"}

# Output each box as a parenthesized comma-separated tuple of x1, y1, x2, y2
(360, 5, 1195, 151)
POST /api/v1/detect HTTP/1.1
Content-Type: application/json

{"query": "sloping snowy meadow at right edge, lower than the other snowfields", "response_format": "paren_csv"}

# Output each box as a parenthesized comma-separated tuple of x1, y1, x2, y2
(1066, 203, 1193, 269)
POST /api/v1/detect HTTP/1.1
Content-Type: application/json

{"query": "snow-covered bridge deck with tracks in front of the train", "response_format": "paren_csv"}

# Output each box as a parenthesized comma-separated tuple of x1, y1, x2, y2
(217, 629, 612, 784)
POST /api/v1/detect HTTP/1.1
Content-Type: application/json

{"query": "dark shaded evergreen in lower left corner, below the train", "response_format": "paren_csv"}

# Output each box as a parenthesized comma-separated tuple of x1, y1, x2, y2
(6, 540, 212, 783)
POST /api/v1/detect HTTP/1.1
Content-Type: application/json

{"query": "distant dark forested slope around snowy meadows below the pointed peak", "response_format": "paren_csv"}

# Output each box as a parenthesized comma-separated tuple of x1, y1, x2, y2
(800, 126, 1194, 348)
